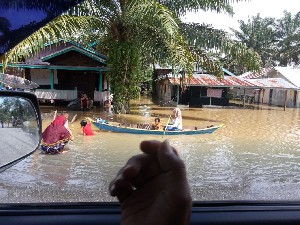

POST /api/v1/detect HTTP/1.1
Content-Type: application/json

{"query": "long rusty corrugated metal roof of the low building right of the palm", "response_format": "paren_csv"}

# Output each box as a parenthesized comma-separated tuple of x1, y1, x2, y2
(168, 74, 298, 89)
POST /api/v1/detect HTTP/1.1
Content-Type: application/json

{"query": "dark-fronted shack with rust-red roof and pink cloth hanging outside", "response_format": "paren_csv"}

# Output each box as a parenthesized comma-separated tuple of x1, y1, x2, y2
(157, 73, 255, 107)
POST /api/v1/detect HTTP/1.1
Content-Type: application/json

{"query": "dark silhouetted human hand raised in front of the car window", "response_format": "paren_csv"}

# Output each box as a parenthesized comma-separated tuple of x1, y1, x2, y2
(109, 141, 192, 225)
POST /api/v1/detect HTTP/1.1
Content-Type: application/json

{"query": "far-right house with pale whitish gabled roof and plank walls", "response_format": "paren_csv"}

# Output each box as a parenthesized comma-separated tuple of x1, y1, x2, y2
(239, 67, 300, 108)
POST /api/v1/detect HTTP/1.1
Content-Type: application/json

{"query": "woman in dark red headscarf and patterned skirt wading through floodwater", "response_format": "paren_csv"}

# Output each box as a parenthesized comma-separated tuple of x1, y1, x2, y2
(41, 112, 74, 154)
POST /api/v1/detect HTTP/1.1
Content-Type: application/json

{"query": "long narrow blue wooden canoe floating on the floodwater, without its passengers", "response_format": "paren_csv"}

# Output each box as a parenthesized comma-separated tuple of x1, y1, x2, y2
(92, 121, 222, 135)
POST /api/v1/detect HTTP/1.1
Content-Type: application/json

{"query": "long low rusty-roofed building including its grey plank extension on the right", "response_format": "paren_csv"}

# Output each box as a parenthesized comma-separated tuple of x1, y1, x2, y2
(157, 67, 298, 107)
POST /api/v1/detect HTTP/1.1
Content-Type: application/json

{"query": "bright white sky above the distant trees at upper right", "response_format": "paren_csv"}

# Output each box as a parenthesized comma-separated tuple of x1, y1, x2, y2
(182, 0, 300, 31)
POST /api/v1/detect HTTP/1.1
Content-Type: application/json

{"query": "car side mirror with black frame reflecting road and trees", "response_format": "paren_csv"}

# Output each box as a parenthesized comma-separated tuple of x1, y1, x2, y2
(0, 91, 42, 172)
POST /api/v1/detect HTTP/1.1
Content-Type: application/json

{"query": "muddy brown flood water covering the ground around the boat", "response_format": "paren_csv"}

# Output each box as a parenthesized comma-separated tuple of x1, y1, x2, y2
(0, 101, 300, 203)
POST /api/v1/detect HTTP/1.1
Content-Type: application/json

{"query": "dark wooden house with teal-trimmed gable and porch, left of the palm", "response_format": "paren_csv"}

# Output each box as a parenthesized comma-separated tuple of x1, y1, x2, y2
(0, 41, 109, 102)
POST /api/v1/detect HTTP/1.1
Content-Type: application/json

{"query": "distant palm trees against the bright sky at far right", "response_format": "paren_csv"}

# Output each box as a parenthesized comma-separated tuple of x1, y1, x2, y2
(232, 11, 300, 71)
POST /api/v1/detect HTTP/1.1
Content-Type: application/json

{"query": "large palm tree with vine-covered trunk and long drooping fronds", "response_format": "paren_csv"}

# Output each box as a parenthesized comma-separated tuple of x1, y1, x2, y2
(4, 0, 260, 112)
